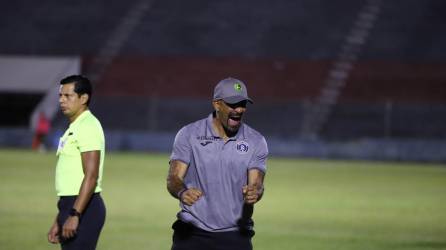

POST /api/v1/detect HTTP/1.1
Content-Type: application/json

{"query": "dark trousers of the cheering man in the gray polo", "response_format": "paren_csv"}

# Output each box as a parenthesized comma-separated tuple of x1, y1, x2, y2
(172, 220, 254, 250)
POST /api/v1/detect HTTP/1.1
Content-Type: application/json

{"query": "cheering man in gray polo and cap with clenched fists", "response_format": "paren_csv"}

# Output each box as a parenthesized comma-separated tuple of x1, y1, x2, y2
(167, 78, 268, 250)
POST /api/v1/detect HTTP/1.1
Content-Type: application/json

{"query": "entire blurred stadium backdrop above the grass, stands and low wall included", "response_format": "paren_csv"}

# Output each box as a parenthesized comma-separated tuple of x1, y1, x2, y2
(0, 0, 446, 162)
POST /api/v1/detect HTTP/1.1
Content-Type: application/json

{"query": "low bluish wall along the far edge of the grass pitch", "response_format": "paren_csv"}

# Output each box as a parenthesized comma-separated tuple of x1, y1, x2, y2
(0, 128, 446, 163)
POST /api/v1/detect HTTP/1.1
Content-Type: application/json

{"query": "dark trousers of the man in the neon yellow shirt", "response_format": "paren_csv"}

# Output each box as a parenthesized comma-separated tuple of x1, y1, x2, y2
(57, 193, 105, 250)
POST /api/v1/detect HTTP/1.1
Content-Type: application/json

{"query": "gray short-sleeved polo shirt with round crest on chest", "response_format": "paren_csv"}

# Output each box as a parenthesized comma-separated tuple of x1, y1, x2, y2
(170, 114, 268, 232)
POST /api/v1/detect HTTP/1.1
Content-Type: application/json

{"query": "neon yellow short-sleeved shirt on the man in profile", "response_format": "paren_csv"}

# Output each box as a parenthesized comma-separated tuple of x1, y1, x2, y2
(56, 110, 105, 196)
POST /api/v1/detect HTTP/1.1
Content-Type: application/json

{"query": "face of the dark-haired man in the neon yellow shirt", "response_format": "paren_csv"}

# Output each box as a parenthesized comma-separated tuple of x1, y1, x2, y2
(59, 83, 88, 121)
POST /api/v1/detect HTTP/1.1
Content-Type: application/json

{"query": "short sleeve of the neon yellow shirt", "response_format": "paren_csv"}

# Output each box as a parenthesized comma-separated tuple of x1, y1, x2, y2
(77, 122, 104, 152)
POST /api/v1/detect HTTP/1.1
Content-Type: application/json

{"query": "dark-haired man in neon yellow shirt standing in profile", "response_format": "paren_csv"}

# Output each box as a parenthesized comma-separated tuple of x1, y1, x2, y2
(48, 75, 105, 250)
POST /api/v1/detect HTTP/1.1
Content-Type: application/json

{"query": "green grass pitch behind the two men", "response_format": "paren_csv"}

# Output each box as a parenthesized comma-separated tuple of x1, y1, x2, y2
(0, 150, 446, 250)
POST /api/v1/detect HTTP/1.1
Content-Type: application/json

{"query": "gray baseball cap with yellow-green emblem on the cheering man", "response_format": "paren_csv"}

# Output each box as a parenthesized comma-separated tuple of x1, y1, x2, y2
(214, 77, 253, 104)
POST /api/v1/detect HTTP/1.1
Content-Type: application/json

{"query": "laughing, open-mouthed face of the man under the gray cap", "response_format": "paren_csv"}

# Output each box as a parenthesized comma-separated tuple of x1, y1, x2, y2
(214, 100, 246, 136)
